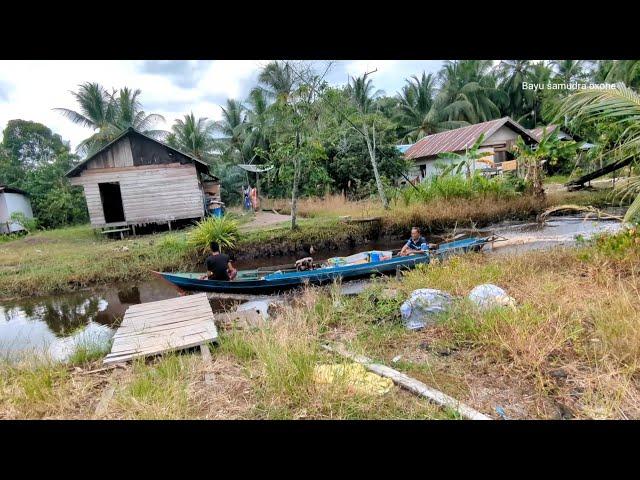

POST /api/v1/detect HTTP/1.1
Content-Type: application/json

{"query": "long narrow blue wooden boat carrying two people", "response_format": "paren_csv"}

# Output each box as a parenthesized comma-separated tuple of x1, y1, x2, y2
(153, 237, 491, 294)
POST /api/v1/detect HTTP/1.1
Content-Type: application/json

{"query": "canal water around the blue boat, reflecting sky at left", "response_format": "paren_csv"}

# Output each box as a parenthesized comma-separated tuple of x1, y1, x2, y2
(0, 217, 621, 361)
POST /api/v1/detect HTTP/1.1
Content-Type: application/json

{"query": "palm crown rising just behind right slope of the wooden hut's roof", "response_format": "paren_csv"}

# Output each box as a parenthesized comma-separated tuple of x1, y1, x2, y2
(167, 112, 215, 160)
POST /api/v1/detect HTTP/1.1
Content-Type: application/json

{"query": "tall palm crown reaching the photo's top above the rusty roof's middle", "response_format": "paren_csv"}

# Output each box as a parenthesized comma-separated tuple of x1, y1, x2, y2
(436, 60, 509, 123)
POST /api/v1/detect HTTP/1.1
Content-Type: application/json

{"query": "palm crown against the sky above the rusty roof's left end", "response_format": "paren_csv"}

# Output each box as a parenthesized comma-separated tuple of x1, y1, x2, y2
(396, 72, 468, 142)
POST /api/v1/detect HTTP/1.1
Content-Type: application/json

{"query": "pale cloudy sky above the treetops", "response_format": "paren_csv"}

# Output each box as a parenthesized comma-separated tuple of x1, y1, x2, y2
(0, 60, 443, 148)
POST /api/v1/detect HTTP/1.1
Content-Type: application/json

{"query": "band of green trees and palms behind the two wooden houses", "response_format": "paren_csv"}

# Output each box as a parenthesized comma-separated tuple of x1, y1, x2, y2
(5, 60, 640, 228)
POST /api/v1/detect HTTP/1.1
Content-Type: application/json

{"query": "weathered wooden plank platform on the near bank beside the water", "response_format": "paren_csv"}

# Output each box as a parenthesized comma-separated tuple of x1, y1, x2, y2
(104, 293, 218, 364)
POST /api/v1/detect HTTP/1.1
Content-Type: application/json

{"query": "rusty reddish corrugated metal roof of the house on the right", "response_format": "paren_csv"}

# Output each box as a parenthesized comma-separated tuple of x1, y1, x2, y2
(405, 117, 537, 159)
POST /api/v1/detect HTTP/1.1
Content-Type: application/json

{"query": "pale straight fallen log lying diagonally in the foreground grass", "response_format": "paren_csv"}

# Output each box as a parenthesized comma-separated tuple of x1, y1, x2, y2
(322, 344, 493, 420)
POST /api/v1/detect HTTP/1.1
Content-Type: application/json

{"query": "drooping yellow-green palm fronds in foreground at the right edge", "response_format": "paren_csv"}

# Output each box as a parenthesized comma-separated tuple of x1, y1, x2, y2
(557, 83, 640, 221)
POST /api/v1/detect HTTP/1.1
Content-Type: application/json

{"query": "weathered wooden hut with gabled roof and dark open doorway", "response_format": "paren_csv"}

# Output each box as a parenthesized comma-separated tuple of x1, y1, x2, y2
(66, 128, 220, 228)
